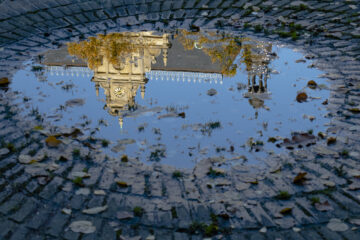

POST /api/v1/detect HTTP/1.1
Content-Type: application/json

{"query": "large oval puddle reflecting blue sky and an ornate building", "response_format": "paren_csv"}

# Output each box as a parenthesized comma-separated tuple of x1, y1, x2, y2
(11, 30, 329, 168)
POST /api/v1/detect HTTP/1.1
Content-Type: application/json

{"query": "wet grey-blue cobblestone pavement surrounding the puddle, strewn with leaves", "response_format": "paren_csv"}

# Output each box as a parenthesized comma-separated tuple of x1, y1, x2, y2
(0, 0, 360, 240)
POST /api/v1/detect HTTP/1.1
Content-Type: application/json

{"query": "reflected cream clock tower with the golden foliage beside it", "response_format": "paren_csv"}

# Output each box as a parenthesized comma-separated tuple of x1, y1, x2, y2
(68, 32, 169, 128)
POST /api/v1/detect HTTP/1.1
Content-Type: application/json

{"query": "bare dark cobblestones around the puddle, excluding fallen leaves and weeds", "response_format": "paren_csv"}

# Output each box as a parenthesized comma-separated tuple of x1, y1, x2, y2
(0, 0, 360, 239)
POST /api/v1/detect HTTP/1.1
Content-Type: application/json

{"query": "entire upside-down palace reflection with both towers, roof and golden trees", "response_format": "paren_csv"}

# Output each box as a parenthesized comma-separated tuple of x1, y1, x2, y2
(45, 30, 276, 128)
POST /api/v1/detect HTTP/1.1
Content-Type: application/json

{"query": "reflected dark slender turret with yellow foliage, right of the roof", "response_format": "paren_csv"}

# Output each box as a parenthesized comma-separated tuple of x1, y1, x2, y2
(176, 30, 276, 117)
